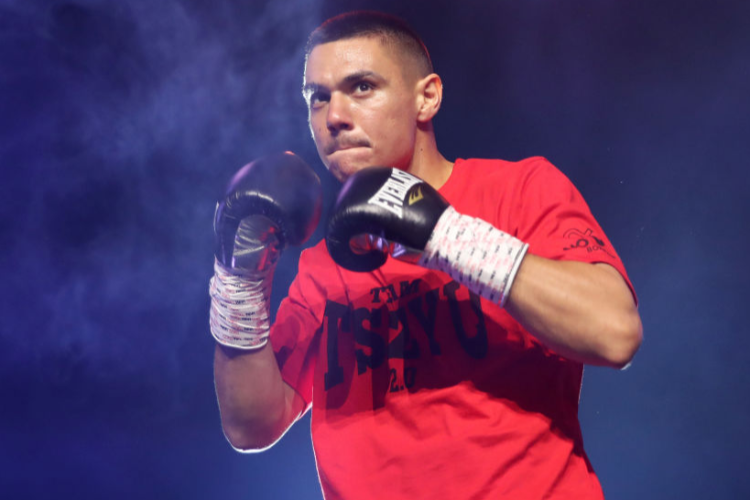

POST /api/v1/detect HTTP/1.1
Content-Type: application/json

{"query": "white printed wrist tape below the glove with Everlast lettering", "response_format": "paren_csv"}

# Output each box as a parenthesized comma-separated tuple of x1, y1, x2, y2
(419, 207, 529, 307)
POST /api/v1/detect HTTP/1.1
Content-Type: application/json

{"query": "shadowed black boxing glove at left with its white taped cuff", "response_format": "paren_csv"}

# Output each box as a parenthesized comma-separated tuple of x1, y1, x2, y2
(210, 153, 322, 349)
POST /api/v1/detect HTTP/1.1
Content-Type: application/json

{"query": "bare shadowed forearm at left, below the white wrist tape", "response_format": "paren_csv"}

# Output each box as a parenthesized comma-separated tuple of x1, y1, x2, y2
(214, 344, 297, 450)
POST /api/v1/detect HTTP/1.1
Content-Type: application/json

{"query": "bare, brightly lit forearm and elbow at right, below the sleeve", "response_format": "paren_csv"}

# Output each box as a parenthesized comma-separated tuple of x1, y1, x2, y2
(505, 254, 642, 368)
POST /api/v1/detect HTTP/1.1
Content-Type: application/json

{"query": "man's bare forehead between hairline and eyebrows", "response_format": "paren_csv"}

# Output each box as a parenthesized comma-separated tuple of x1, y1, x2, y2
(305, 36, 401, 85)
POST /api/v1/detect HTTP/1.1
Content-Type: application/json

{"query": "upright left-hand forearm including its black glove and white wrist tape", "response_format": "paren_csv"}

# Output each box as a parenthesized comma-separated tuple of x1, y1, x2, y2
(209, 152, 322, 450)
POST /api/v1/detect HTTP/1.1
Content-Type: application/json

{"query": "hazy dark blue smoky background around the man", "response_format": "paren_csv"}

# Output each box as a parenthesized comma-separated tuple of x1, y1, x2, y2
(0, 0, 750, 500)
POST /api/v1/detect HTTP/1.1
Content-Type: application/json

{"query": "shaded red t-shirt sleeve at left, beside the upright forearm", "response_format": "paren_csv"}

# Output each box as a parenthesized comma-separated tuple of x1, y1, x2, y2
(271, 246, 325, 408)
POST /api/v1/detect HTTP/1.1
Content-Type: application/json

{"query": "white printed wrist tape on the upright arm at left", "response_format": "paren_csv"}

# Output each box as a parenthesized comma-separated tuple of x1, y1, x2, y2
(209, 262, 273, 349)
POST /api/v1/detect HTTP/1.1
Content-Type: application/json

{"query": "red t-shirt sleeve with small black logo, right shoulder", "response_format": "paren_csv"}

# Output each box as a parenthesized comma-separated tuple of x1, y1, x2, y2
(516, 157, 636, 298)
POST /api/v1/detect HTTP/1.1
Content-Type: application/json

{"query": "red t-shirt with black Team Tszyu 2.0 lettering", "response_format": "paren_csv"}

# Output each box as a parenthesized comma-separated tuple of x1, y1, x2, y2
(271, 157, 632, 500)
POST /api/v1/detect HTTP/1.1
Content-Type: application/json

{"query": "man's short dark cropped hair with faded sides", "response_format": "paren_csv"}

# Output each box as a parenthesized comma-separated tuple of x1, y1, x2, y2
(305, 10, 433, 76)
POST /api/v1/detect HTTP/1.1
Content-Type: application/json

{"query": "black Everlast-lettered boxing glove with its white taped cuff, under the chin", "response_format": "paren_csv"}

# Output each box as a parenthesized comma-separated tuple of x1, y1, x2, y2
(326, 167, 528, 306)
